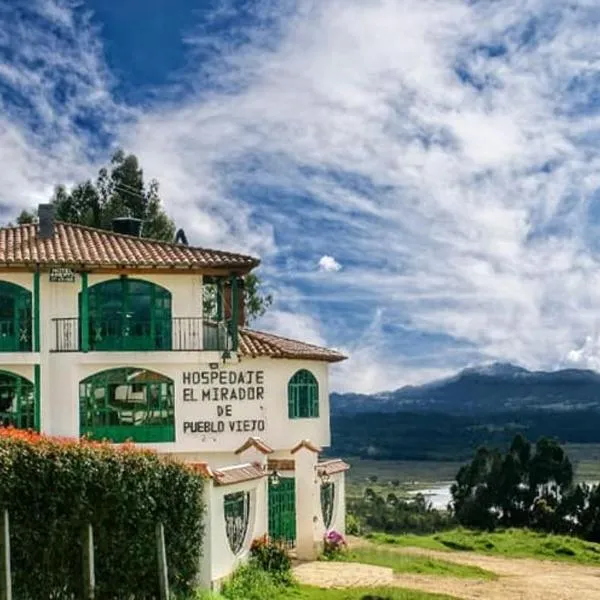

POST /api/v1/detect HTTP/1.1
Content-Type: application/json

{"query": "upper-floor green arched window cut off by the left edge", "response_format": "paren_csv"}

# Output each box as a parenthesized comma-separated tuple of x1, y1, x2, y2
(0, 281, 31, 352)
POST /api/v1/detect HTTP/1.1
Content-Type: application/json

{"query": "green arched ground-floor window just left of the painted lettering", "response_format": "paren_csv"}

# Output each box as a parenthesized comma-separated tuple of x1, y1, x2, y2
(79, 368, 175, 443)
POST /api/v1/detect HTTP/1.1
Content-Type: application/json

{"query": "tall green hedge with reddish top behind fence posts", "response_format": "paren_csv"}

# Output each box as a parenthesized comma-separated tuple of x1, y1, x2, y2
(0, 429, 204, 600)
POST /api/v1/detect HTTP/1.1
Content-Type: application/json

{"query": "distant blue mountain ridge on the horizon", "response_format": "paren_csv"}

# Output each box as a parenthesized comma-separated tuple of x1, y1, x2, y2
(331, 363, 600, 415)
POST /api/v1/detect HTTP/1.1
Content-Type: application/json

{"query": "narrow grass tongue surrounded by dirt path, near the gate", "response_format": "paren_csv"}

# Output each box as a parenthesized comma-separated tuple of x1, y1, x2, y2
(340, 548, 496, 579)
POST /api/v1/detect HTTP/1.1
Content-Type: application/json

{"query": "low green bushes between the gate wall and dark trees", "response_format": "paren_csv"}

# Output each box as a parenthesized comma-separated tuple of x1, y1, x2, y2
(347, 488, 456, 533)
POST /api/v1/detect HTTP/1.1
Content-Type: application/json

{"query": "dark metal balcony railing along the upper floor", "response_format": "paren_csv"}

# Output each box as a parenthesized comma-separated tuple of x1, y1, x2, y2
(52, 317, 232, 352)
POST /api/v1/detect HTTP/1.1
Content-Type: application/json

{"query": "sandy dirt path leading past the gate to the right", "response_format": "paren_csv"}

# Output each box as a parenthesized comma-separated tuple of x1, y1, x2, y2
(295, 548, 600, 600)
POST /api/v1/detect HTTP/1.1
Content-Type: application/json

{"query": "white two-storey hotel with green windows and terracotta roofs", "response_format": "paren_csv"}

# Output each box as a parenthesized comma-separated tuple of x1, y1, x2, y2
(0, 205, 347, 584)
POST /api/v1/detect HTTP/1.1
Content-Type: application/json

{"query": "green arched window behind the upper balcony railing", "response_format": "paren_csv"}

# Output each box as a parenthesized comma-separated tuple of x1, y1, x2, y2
(83, 277, 171, 351)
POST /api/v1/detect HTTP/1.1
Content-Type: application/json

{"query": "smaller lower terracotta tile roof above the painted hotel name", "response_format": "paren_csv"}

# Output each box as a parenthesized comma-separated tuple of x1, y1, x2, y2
(240, 329, 346, 362)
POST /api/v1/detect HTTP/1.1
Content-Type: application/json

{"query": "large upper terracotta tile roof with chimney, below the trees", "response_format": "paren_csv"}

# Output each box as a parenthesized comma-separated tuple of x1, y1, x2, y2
(0, 221, 259, 271)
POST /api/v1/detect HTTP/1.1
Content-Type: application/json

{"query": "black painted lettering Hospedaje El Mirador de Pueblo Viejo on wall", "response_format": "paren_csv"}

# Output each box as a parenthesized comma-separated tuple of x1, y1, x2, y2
(178, 368, 266, 442)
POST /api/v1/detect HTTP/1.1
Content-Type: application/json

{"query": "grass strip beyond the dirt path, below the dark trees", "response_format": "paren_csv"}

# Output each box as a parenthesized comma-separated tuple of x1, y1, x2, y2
(368, 529, 600, 566)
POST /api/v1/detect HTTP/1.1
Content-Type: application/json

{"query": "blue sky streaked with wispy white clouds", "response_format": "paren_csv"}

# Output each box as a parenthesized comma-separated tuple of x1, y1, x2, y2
(0, 0, 600, 391)
